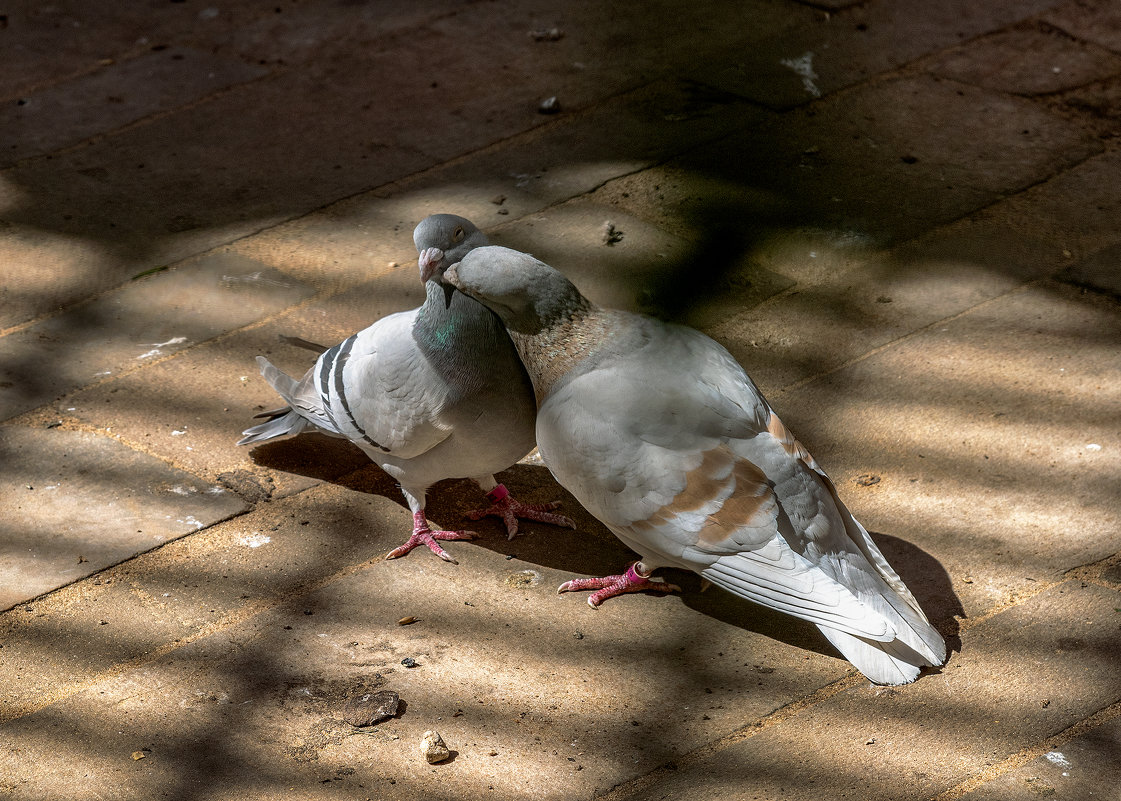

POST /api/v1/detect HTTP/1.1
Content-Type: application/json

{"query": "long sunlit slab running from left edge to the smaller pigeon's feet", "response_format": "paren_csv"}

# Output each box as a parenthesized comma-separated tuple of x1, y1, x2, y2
(2, 486, 396, 719)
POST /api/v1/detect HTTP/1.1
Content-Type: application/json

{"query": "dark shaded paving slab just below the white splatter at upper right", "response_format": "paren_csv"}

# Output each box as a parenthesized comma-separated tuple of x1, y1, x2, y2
(654, 75, 1101, 244)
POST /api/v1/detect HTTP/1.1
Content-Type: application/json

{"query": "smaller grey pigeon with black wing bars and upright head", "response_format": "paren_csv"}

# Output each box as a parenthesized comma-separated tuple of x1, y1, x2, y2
(239, 214, 575, 564)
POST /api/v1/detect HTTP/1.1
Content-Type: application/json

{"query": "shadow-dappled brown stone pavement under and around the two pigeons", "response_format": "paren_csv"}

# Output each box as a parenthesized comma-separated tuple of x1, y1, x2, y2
(0, 0, 1121, 801)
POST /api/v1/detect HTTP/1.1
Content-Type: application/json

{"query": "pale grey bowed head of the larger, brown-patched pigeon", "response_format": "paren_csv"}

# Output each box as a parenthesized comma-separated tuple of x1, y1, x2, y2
(444, 245, 590, 334)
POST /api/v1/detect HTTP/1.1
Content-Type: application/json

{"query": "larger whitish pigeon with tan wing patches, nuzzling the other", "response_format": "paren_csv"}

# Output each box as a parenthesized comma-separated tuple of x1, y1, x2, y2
(444, 246, 946, 684)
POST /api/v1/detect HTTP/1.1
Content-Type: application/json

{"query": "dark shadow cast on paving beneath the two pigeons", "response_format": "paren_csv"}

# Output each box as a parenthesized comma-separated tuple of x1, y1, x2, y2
(250, 432, 964, 672)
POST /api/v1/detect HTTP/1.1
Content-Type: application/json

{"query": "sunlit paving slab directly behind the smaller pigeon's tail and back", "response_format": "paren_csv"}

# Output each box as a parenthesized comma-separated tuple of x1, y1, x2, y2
(54, 256, 434, 481)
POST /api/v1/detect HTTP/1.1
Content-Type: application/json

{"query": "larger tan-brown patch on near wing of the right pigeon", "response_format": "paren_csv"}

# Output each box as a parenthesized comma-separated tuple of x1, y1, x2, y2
(633, 445, 773, 548)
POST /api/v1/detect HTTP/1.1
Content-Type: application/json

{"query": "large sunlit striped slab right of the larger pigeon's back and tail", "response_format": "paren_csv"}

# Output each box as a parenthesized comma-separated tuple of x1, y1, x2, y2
(770, 283, 1121, 616)
